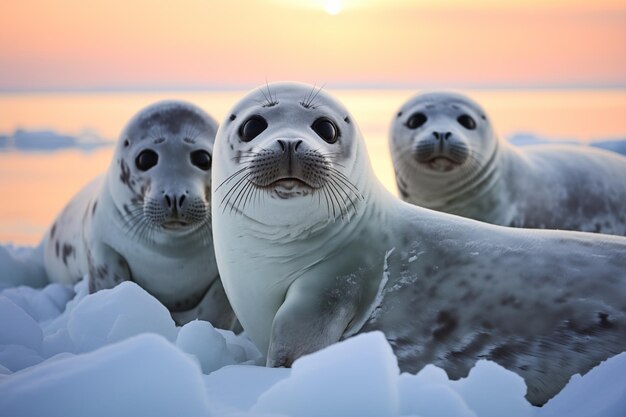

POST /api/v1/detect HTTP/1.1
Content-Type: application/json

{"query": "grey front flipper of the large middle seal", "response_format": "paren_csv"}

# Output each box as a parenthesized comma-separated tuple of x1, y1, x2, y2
(266, 276, 361, 367)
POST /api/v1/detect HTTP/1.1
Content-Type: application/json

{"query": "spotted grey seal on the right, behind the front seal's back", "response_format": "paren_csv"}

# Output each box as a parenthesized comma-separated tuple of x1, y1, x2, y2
(389, 92, 626, 236)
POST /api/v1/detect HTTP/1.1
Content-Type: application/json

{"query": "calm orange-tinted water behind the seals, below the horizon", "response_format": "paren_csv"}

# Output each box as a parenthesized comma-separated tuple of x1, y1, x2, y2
(0, 90, 626, 244)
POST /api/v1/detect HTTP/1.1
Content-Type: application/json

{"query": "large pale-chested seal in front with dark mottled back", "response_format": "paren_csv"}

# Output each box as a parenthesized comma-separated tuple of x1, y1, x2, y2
(212, 83, 626, 404)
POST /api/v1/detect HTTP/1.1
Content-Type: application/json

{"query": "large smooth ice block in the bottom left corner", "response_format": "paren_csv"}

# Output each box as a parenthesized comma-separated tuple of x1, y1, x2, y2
(0, 335, 210, 417)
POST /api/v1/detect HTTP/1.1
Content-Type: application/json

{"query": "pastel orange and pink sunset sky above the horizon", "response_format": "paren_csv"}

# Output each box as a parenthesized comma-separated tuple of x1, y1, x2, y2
(0, 0, 626, 90)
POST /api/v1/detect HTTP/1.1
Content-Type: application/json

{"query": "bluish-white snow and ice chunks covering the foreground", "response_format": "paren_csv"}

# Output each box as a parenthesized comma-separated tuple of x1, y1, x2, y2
(0, 242, 626, 417)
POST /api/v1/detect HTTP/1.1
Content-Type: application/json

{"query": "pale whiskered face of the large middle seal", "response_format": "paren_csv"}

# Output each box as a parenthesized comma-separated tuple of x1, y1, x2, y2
(216, 83, 363, 228)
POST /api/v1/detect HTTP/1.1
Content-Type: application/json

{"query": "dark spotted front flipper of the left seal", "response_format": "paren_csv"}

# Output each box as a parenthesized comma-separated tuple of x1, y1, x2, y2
(87, 243, 131, 294)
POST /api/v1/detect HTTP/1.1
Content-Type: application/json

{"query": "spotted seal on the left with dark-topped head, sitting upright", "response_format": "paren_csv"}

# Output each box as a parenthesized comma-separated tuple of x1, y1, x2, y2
(43, 101, 237, 328)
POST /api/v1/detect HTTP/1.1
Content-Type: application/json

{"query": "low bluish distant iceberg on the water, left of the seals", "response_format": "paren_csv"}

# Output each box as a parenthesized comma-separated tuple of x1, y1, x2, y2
(0, 129, 114, 152)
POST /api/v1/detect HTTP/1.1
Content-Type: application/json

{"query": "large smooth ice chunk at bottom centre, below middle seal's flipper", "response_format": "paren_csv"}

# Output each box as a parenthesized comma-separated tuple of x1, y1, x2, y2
(252, 332, 400, 417)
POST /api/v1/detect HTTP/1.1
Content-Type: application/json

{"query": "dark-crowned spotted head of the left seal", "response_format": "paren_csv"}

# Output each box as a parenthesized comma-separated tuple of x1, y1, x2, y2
(109, 102, 217, 239)
